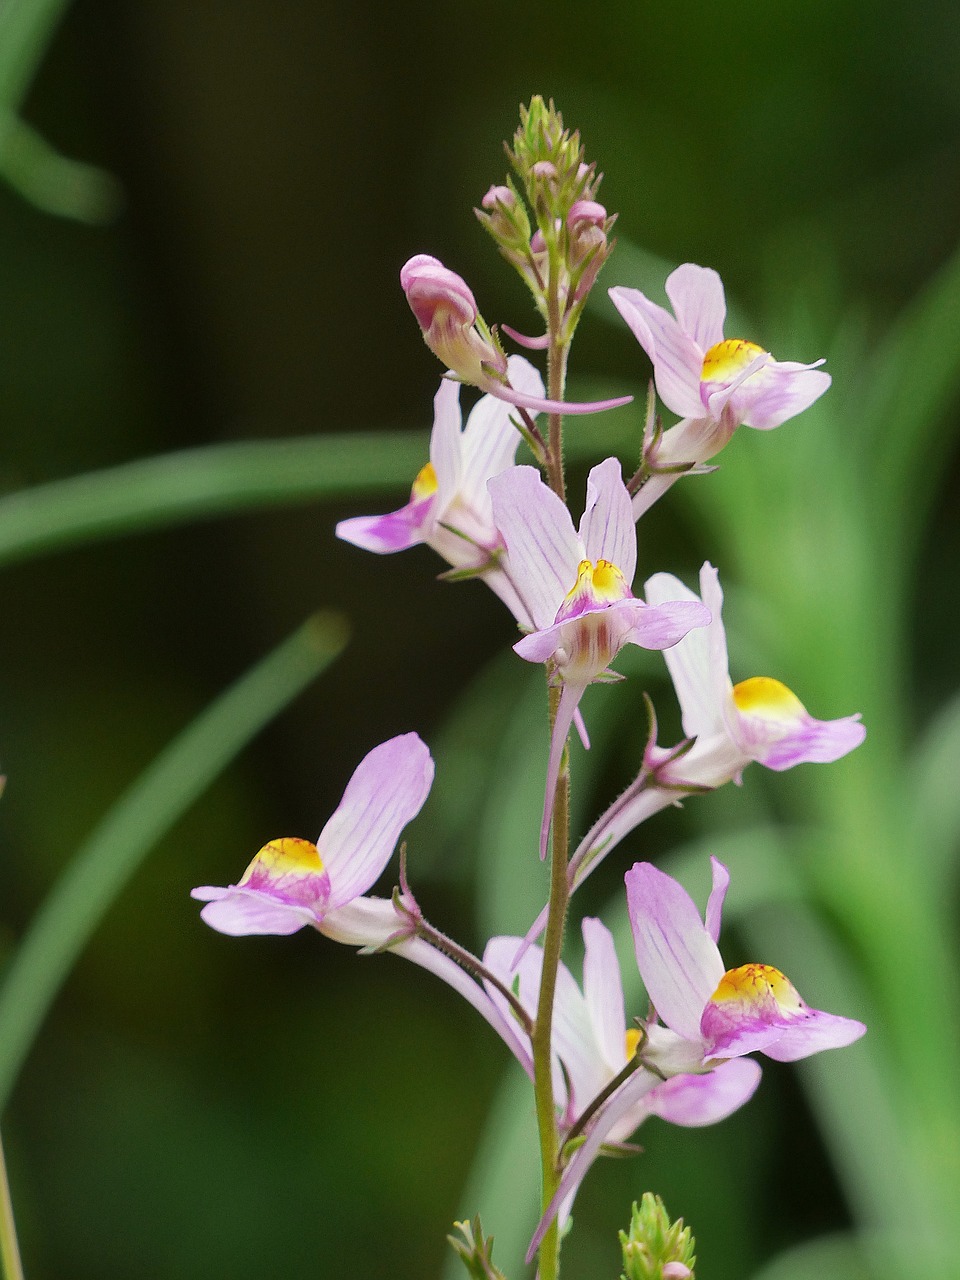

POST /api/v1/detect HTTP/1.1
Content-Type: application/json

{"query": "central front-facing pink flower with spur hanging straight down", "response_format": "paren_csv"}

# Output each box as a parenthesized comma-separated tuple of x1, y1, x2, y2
(490, 458, 710, 858)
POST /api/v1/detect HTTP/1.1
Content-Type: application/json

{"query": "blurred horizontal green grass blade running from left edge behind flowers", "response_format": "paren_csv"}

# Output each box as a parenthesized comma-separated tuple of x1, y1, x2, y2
(0, 412, 640, 564)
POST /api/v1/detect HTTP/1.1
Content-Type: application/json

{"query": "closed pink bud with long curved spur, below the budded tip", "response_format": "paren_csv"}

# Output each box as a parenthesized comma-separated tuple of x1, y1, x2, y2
(401, 253, 632, 413)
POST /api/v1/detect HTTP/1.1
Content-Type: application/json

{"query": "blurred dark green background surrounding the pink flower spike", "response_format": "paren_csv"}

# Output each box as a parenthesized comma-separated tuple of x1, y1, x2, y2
(0, 0, 960, 1280)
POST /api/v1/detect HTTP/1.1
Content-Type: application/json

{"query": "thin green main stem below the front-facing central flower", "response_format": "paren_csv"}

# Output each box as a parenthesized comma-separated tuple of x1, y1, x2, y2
(531, 689, 570, 1280)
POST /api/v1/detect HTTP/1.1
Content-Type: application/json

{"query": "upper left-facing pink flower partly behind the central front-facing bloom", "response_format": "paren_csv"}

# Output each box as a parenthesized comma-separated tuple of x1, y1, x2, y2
(337, 356, 543, 626)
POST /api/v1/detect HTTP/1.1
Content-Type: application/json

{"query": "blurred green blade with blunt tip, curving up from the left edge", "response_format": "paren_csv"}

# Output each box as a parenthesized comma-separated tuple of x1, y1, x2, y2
(0, 614, 346, 1110)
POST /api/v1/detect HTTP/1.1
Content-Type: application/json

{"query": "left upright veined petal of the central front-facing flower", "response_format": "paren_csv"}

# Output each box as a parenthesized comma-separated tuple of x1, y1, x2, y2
(489, 467, 584, 627)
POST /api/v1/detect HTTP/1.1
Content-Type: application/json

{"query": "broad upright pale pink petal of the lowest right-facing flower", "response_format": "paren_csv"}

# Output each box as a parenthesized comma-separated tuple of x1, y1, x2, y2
(626, 863, 724, 1042)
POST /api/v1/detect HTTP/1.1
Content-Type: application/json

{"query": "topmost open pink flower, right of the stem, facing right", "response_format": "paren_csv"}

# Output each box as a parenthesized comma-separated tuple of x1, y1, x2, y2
(609, 262, 831, 516)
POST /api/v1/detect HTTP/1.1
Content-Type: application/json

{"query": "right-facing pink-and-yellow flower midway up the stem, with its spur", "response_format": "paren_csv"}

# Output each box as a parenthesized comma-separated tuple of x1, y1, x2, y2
(568, 563, 867, 896)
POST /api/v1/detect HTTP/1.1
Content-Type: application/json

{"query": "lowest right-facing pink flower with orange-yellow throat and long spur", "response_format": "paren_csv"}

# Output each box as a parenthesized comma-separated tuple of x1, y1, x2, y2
(527, 858, 867, 1258)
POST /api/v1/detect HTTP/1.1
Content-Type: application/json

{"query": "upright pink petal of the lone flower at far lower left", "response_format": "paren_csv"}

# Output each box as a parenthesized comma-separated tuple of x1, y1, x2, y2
(317, 733, 434, 908)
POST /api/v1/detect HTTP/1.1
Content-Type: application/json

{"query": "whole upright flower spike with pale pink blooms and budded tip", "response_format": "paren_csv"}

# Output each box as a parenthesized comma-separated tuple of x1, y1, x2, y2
(193, 99, 864, 1277)
